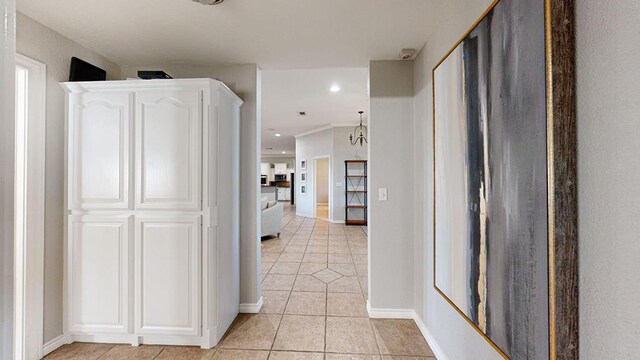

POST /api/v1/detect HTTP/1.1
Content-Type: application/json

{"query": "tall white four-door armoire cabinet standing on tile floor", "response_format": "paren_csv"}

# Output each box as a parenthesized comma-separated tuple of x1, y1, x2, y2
(62, 79, 242, 348)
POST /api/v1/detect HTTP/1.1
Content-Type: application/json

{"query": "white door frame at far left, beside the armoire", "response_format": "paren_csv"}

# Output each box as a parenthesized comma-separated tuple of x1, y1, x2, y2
(14, 54, 47, 359)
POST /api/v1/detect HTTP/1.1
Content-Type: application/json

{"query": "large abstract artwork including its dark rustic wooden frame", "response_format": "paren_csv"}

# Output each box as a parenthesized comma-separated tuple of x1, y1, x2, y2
(432, 0, 578, 360)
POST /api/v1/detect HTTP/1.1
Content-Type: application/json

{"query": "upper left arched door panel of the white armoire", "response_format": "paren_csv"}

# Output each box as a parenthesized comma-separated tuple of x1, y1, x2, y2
(68, 93, 131, 209)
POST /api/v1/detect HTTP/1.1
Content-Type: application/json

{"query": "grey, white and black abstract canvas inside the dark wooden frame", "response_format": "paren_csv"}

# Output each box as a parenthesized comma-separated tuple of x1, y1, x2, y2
(435, 0, 549, 359)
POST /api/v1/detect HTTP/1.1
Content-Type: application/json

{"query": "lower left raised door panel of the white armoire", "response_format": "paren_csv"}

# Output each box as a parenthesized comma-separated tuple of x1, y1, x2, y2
(68, 216, 129, 333)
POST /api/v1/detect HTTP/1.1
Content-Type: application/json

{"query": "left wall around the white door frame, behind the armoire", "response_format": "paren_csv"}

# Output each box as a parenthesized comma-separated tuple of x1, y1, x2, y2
(17, 13, 120, 342)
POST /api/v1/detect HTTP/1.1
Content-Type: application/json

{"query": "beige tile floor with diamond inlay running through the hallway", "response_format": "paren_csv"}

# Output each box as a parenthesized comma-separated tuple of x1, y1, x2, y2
(46, 206, 435, 360)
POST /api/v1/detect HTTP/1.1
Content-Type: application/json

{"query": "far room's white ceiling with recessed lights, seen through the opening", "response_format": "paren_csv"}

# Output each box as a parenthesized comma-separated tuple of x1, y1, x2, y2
(262, 68, 369, 155)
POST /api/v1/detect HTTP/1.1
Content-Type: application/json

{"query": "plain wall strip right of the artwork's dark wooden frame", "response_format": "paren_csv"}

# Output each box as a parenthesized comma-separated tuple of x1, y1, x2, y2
(576, 0, 640, 360)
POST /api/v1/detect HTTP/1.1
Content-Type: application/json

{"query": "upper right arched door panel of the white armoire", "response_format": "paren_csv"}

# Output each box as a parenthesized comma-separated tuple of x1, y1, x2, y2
(136, 91, 202, 210)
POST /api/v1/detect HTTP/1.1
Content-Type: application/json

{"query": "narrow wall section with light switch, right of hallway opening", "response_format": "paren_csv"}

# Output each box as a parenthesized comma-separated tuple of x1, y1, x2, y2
(369, 61, 414, 311)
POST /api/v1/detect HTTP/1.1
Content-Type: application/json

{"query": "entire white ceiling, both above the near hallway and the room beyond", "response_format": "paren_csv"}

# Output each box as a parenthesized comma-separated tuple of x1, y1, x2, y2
(17, 0, 440, 154)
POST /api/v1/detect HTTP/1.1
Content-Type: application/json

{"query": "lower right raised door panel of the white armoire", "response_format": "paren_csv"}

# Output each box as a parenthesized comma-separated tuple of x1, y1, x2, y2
(136, 216, 200, 335)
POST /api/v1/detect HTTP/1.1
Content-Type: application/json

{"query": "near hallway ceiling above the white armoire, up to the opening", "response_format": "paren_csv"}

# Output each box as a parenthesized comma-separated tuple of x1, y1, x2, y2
(17, 0, 446, 69)
